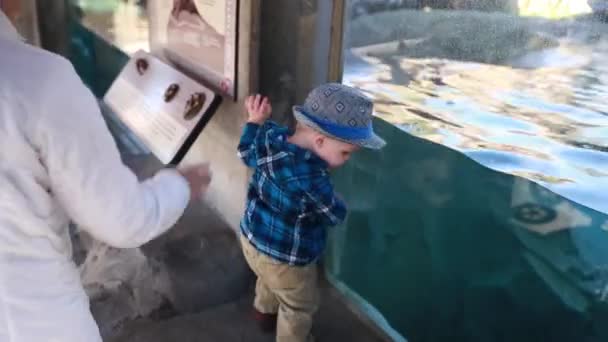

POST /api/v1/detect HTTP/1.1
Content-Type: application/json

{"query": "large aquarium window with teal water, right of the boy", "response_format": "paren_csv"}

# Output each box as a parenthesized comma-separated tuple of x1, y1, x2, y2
(328, 0, 608, 342)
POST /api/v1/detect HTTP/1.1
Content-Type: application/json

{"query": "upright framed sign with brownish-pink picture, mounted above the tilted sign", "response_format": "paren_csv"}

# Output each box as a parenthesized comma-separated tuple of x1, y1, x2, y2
(149, 0, 238, 98)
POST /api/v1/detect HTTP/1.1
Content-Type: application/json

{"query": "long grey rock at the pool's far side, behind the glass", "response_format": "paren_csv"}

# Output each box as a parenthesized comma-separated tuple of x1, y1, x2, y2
(347, 10, 558, 64)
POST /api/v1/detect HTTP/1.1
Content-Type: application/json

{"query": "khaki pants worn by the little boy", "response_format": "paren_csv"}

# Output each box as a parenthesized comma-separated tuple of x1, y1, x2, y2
(241, 235, 319, 342)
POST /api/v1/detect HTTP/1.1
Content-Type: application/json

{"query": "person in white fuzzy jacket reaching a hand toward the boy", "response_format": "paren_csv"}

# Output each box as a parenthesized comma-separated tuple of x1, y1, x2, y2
(0, 11, 210, 342)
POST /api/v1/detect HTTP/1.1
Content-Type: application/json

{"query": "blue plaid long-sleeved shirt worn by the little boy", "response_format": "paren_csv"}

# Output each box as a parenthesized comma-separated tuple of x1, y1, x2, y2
(238, 121, 346, 266)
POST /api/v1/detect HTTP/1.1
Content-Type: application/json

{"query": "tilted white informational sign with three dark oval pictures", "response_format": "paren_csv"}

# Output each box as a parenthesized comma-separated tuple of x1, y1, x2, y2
(104, 51, 221, 165)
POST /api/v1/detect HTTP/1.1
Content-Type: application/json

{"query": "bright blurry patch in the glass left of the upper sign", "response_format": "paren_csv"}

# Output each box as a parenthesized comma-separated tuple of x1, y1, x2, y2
(71, 0, 150, 54)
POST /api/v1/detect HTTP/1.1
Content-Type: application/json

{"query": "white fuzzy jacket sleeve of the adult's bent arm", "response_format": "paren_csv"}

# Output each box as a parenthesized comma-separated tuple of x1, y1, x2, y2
(34, 59, 190, 248)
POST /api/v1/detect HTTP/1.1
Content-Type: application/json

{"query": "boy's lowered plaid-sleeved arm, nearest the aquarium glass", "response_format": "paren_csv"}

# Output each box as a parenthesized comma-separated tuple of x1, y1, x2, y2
(306, 177, 347, 226)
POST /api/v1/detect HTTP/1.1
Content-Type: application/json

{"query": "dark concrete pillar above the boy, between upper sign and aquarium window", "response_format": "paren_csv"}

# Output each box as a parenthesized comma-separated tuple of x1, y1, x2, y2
(259, 0, 335, 124)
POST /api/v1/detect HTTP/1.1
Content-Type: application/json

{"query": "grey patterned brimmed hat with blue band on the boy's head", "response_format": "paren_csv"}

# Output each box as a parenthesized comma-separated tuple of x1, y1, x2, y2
(293, 83, 386, 150)
